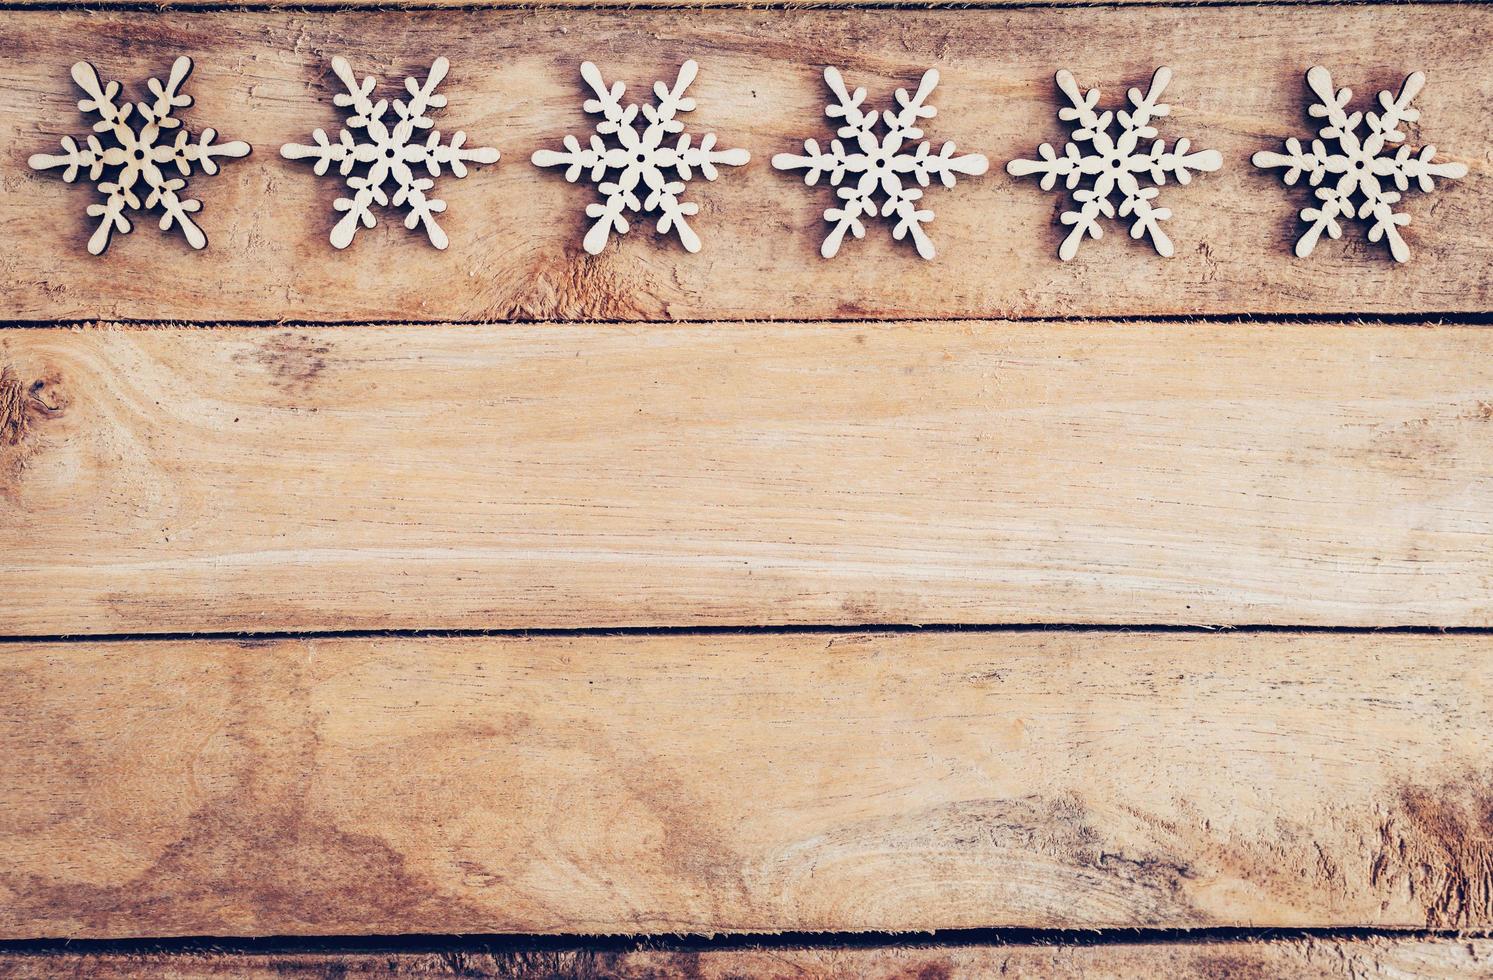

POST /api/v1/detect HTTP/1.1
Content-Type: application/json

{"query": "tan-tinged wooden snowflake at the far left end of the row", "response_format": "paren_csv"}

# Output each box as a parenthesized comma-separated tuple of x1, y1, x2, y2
(27, 57, 249, 255)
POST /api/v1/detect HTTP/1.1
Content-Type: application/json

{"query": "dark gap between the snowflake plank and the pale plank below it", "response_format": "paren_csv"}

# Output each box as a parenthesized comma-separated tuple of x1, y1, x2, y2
(0, 311, 1493, 332)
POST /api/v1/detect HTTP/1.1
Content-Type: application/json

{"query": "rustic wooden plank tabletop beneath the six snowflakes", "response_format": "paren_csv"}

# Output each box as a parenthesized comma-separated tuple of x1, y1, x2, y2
(0, 0, 1493, 979)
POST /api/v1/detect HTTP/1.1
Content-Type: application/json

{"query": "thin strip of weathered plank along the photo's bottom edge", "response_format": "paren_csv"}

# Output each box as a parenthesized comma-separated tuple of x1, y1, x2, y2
(0, 937, 1493, 980)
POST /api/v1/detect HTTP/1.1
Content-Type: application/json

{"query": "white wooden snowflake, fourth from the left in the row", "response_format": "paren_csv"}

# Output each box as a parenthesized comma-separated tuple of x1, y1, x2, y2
(772, 66, 990, 258)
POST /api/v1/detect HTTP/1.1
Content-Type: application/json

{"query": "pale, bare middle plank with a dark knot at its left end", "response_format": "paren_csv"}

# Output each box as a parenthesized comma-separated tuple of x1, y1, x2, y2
(0, 323, 1493, 635)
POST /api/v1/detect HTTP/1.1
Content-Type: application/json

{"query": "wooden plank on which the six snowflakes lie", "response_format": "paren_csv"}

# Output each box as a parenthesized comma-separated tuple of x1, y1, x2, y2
(0, 4, 1493, 321)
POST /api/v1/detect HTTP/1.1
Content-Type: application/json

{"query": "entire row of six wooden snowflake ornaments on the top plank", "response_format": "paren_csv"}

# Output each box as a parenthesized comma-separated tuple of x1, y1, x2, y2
(30, 57, 1468, 261)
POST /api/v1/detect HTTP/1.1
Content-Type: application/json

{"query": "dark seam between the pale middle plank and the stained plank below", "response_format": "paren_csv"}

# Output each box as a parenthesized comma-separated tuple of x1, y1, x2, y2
(0, 623, 1493, 645)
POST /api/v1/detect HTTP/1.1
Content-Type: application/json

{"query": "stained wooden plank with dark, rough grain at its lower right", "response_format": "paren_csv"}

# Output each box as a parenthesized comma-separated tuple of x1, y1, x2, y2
(0, 632, 1493, 938)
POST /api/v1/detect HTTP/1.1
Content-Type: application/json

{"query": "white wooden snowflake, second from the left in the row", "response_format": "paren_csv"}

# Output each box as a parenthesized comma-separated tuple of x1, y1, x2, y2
(281, 55, 499, 248)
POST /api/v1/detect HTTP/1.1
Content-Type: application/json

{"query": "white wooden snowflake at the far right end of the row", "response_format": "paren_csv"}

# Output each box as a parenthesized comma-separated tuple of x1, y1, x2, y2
(1254, 66, 1468, 261)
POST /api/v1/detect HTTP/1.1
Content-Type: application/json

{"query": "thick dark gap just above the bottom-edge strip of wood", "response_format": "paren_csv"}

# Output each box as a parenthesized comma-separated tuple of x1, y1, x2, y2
(0, 926, 1493, 956)
